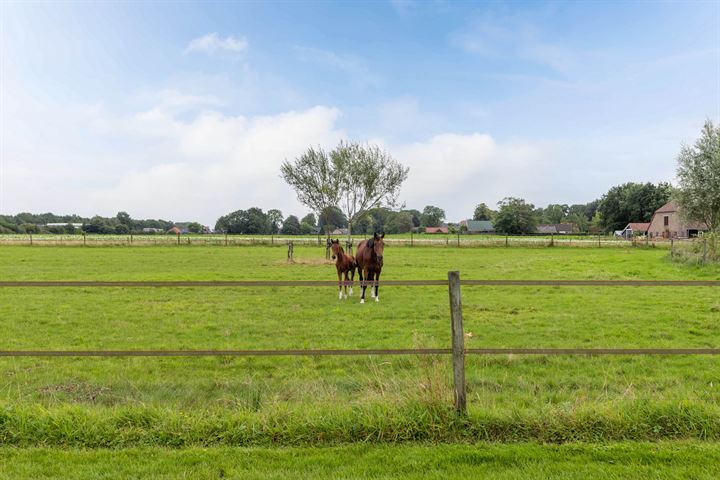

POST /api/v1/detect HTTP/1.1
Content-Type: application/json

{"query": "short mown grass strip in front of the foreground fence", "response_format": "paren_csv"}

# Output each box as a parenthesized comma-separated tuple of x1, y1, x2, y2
(0, 442, 720, 480)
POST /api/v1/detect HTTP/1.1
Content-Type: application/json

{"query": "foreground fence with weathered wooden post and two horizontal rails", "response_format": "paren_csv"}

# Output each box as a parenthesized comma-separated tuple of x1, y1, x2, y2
(0, 271, 720, 412)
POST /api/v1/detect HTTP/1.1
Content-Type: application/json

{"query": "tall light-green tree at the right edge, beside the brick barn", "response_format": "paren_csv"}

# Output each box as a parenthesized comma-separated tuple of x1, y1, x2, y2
(677, 120, 720, 232)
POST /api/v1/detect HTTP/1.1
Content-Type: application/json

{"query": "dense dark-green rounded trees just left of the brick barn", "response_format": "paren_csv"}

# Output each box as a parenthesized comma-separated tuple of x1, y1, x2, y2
(597, 183, 672, 232)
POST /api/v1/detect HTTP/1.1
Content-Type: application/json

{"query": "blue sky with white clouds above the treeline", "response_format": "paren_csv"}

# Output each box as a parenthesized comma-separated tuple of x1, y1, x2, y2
(0, 1, 720, 224)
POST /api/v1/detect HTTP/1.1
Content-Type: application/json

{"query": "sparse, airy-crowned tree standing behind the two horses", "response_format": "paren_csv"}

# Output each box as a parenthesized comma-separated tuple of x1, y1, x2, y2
(281, 142, 408, 238)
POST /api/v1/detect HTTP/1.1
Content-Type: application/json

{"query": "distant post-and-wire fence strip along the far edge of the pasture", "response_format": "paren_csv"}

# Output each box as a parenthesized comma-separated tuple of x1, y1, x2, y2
(0, 234, 702, 250)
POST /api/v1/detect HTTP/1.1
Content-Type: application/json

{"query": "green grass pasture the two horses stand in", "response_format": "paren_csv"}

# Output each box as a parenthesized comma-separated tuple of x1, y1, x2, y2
(0, 246, 720, 447)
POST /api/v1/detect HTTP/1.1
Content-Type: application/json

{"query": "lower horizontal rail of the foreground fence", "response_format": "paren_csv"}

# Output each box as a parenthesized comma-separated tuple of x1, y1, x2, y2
(0, 348, 720, 357)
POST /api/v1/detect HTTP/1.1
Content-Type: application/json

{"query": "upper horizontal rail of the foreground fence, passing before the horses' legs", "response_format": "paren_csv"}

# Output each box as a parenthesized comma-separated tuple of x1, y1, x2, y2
(0, 280, 720, 288)
